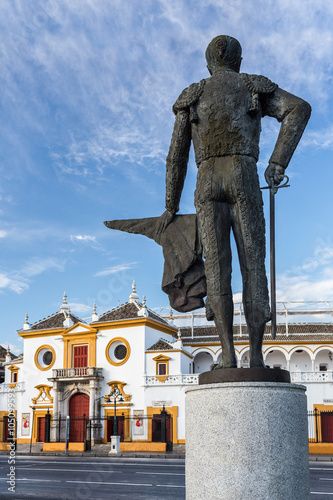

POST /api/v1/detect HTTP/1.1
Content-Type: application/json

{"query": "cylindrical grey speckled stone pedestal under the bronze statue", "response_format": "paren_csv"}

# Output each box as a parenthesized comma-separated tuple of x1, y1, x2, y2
(186, 382, 310, 500)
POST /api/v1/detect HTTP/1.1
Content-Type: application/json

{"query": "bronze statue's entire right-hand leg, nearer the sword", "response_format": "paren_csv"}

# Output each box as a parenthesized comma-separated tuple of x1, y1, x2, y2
(231, 157, 270, 368)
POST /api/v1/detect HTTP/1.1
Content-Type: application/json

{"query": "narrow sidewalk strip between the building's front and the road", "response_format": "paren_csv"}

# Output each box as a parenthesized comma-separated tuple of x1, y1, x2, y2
(0, 443, 185, 459)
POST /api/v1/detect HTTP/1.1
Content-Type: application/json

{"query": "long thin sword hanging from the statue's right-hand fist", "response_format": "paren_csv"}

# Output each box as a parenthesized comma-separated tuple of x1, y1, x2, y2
(261, 175, 289, 339)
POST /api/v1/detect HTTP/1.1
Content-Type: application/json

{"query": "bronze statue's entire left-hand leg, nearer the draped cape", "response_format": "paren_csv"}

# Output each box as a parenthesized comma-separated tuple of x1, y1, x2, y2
(196, 193, 237, 368)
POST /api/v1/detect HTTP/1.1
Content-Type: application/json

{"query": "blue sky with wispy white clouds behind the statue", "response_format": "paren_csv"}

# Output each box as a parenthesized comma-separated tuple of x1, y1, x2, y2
(0, 0, 333, 352)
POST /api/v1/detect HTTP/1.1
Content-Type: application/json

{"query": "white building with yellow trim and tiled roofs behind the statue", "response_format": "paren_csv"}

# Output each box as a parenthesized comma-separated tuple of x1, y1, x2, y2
(0, 284, 333, 454)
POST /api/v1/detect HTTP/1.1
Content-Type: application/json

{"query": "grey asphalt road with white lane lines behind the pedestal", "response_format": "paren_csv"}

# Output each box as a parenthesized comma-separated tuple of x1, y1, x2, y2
(0, 455, 333, 500)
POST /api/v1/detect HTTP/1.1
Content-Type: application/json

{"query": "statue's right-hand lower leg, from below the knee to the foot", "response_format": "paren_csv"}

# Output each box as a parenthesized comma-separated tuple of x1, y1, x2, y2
(244, 302, 267, 368)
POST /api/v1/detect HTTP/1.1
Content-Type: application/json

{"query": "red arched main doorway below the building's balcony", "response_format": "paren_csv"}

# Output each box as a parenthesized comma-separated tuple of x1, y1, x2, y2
(69, 392, 89, 443)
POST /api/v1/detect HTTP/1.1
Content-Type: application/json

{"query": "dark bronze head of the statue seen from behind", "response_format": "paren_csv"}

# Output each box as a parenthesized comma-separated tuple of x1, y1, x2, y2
(206, 35, 242, 75)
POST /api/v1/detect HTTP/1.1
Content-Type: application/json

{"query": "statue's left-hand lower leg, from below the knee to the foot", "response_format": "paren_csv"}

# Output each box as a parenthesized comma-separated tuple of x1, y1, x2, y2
(209, 295, 237, 369)
